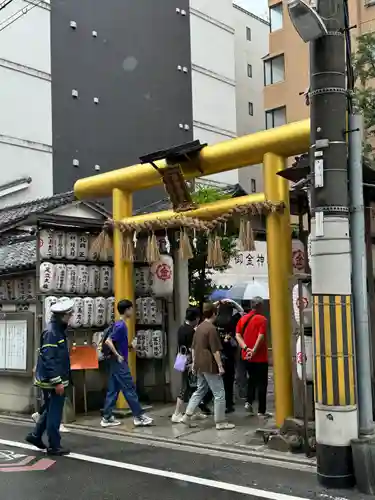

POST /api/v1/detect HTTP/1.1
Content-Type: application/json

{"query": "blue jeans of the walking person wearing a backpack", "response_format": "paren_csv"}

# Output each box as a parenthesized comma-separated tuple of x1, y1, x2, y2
(103, 359, 143, 419)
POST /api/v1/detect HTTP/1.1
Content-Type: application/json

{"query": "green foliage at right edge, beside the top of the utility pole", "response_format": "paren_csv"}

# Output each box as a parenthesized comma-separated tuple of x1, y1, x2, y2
(352, 33, 375, 167)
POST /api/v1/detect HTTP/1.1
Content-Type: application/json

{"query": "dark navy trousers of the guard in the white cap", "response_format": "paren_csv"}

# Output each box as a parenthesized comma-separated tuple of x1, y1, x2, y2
(34, 390, 65, 450)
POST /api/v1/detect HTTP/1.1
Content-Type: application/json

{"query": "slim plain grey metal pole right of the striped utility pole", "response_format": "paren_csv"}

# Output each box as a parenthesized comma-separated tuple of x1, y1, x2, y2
(349, 114, 374, 435)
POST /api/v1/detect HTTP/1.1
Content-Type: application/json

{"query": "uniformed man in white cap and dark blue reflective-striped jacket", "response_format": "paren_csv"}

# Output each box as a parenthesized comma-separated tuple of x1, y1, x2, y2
(26, 299, 74, 456)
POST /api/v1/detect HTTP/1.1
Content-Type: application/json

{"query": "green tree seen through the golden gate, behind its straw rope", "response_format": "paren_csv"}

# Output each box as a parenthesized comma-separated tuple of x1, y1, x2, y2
(189, 186, 237, 305)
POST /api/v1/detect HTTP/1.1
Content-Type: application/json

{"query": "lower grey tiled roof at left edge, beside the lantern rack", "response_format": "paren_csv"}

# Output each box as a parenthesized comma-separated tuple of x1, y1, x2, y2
(0, 239, 36, 274)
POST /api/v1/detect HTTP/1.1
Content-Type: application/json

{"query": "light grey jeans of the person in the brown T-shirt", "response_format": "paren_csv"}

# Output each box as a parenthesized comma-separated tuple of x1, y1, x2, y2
(186, 373, 225, 424)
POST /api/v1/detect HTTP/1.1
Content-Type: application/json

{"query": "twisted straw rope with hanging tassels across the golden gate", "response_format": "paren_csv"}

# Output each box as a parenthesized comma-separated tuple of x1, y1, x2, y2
(93, 201, 285, 267)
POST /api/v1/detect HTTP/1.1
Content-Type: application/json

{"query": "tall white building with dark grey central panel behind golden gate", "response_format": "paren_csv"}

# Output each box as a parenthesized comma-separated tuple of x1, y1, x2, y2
(0, 0, 267, 208)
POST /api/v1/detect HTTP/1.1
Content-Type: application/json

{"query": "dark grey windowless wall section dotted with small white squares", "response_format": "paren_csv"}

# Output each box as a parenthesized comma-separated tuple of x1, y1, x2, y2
(51, 0, 193, 209)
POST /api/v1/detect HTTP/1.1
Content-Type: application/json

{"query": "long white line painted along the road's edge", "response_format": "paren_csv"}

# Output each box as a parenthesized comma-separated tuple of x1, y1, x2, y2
(0, 439, 314, 500)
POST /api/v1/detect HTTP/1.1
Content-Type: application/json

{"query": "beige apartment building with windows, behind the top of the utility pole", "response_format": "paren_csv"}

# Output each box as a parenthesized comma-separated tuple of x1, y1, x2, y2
(264, 0, 375, 132)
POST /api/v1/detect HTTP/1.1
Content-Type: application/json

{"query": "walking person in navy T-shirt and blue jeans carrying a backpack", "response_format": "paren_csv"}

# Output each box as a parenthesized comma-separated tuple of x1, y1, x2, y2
(100, 299, 153, 427)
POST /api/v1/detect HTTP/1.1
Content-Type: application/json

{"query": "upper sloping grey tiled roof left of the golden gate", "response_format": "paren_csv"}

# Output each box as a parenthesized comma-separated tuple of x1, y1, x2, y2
(0, 191, 74, 232)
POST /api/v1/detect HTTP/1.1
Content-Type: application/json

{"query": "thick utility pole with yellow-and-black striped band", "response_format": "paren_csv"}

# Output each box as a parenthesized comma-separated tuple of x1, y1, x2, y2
(310, 0, 358, 488)
